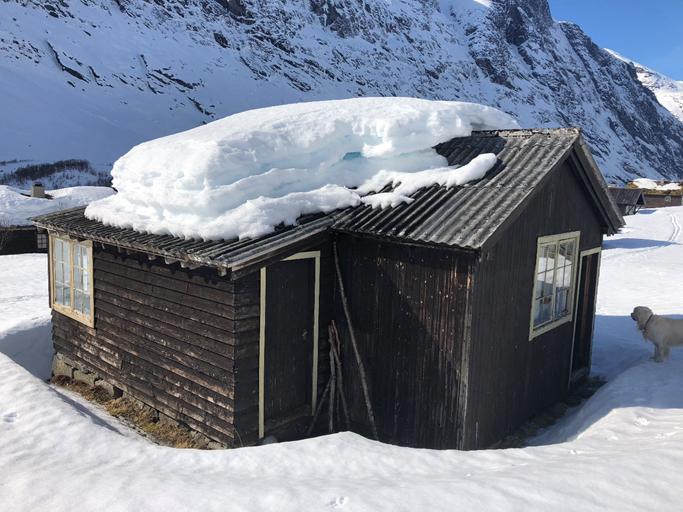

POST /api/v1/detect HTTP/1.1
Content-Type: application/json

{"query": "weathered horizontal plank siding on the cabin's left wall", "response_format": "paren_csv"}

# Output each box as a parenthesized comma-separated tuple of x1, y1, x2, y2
(52, 244, 242, 445)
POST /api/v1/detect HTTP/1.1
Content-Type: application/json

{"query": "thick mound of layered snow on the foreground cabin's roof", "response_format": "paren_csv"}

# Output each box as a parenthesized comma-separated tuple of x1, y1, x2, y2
(86, 98, 516, 239)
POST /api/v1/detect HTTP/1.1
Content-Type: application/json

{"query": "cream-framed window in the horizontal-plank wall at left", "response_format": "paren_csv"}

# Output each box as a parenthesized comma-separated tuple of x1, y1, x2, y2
(50, 235, 94, 327)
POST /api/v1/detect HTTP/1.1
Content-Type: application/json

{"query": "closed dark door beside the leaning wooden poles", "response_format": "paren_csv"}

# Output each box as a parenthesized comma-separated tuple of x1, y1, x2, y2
(262, 258, 316, 435)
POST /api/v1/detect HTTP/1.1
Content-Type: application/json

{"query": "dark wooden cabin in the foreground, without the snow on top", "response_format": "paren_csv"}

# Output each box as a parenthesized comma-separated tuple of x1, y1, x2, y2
(35, 129, 623, 449)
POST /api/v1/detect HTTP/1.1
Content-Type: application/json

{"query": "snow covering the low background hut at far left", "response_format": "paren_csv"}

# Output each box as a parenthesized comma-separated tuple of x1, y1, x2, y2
(0, 185, 114, 226)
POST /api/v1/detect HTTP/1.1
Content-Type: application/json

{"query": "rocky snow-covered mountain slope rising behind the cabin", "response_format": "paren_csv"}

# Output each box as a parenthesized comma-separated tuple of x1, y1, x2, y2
(0, 0, 683, 184)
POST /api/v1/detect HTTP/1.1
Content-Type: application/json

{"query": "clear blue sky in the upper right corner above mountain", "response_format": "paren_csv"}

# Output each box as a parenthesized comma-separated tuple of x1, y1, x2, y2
(550, 0, 683, 80)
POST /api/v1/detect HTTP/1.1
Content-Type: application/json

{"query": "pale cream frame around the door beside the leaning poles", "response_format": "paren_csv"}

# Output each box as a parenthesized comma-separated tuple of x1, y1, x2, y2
(258, 251, 320, 439)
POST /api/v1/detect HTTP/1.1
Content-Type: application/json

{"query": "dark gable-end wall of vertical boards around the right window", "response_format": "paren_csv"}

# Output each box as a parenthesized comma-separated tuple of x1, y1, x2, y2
(463, 160, 602, 449)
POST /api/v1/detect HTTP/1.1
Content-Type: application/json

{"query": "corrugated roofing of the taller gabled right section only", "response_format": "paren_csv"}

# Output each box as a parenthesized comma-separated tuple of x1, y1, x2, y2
(334, 129, 622, 249)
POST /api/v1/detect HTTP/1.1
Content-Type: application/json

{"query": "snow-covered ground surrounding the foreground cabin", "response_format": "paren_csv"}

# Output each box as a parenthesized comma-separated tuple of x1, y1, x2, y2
(0, 208, 683, 512)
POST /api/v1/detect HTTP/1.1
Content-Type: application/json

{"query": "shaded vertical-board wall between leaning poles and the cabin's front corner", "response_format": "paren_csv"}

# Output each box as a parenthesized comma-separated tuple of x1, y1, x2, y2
(335, 235, 472, 448)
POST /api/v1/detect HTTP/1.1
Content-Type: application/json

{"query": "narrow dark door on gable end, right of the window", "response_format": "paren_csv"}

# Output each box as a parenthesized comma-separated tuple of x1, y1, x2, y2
(571, 252, 600, 384)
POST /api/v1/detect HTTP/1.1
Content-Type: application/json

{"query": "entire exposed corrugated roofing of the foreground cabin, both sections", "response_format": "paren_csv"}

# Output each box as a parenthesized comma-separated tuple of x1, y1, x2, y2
(33, 129, 623, 270)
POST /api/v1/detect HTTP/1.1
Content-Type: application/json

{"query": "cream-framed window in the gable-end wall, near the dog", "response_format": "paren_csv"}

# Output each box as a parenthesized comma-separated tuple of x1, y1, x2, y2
(529, 231, 579, 339)
